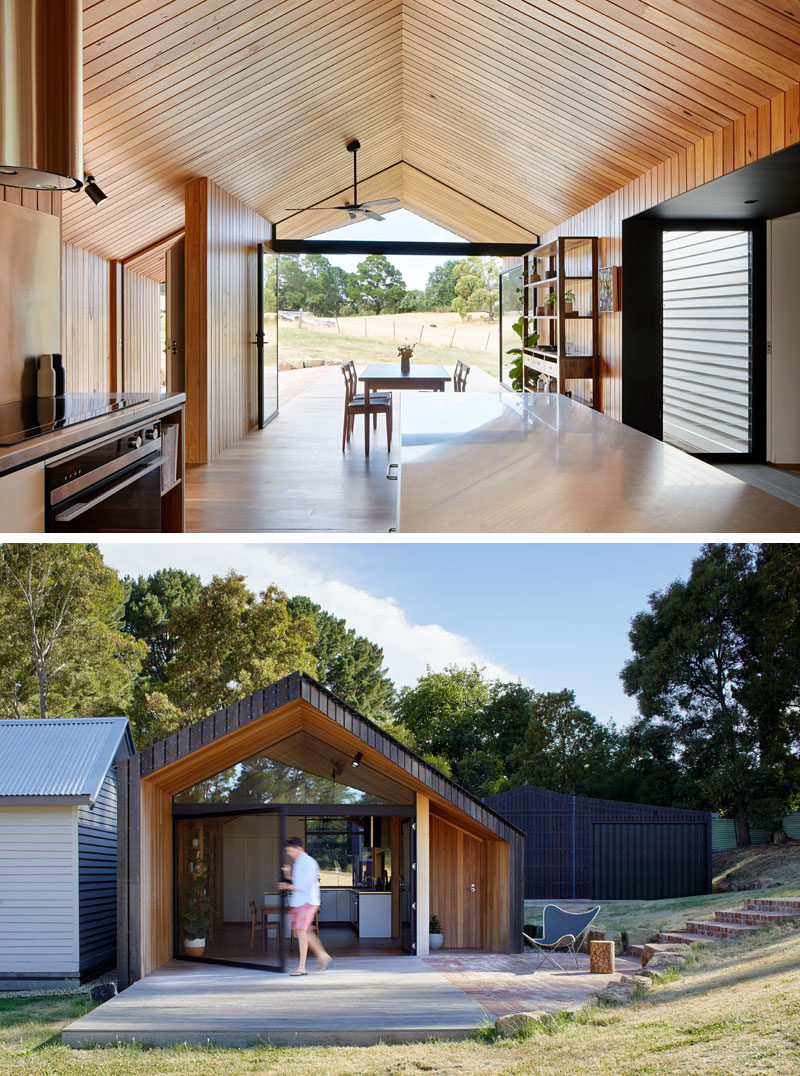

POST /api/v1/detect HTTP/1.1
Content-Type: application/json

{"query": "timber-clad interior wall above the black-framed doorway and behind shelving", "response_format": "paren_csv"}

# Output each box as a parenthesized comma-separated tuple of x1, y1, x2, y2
(542, 84, 800, 420)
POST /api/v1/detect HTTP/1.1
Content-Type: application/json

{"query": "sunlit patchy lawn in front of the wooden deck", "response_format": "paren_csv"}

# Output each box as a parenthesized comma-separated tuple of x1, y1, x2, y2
(0, 925, 800, 1076)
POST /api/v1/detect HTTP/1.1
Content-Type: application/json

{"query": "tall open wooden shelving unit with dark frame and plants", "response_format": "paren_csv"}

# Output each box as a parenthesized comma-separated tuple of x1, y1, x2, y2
(522, 236, 600, 408)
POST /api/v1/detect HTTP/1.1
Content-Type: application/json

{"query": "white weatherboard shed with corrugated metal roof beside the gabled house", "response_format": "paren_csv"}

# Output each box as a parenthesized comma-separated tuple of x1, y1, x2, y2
(0, 718, 134, 990)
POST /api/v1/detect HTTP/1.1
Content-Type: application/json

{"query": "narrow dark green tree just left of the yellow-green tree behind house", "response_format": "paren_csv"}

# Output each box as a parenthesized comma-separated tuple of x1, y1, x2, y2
(125, 568, 202, 675)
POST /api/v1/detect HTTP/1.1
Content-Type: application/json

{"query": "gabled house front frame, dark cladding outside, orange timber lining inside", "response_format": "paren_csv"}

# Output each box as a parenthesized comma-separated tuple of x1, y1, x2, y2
(117, 673, 524, 988)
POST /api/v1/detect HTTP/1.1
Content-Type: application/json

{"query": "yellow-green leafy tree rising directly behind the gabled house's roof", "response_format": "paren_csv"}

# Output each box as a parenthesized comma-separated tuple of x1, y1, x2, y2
(134, 571, 315, 747)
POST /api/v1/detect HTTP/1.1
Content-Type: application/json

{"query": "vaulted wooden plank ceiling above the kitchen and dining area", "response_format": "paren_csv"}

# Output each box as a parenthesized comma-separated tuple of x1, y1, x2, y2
(64, 0, 800, 258)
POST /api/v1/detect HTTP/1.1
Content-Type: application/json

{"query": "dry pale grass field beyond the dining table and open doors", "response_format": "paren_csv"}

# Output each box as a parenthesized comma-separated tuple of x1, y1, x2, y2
(278, 325, 499, 378)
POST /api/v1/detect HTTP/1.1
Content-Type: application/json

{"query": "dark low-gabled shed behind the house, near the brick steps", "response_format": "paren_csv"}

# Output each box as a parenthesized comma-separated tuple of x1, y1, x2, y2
(486, 784, 712, 901)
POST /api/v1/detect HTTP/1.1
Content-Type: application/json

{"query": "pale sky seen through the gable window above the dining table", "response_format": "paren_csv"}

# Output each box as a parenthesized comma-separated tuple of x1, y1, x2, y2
(311, 209, 466, 292)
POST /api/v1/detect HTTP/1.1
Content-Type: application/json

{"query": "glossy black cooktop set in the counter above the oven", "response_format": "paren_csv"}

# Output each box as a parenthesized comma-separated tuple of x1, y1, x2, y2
(0, 393, 150, 448)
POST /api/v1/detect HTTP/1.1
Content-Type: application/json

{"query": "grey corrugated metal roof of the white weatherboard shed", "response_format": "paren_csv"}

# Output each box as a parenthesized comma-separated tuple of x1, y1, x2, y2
(0, 718, 134, 803)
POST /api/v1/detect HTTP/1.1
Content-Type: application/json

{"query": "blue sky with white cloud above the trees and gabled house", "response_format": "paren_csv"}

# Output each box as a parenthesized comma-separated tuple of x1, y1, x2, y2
(100, 540, 700, 726)
